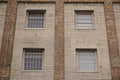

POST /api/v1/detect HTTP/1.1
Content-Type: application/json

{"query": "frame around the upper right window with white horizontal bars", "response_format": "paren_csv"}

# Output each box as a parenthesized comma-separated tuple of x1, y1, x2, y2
(74, 10, 95, 30)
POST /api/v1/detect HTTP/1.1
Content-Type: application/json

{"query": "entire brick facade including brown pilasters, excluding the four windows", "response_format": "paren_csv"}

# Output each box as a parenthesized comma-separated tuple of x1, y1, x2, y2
(0, 0, 120, 80)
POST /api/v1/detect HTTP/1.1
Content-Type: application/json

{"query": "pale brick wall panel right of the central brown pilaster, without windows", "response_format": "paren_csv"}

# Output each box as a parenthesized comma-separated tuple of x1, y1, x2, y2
(64, 3, 111, 80)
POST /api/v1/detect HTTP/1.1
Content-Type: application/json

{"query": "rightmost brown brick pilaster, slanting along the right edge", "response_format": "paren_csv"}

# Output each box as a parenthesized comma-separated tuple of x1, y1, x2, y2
(104, 0, 120, 80)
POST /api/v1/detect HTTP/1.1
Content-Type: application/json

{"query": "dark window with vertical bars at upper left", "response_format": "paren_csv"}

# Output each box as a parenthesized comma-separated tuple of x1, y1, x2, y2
(27, 10, 45, 28)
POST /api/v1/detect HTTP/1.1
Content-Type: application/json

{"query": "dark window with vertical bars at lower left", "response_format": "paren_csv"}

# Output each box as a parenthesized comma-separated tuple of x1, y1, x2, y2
(23, 48, 44, 70)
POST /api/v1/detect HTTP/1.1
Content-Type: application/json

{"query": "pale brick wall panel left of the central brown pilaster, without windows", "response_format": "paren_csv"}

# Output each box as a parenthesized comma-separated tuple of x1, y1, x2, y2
(10, 3, 55, 80)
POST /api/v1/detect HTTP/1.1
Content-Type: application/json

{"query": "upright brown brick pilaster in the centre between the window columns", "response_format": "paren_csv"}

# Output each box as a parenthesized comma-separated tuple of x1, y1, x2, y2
(54, 0, 65, 80)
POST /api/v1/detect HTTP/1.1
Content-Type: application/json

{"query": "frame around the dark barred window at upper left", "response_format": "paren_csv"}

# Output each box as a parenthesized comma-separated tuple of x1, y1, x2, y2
(26, 9, 46, 29)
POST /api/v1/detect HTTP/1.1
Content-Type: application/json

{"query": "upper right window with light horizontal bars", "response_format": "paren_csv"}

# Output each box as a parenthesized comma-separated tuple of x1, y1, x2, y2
(75, 11, 93, 29)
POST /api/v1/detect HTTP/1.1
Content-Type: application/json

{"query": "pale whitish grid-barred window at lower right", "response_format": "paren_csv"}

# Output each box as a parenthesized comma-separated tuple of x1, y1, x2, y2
(77, 49, 97, 72)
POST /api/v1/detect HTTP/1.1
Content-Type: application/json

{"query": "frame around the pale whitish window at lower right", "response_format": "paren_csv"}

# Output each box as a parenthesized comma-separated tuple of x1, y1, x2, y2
(76, 48, 98, 72)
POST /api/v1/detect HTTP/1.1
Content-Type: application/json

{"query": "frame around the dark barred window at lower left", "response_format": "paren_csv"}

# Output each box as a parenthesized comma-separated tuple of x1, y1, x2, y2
(22, 48, 45, 71)
